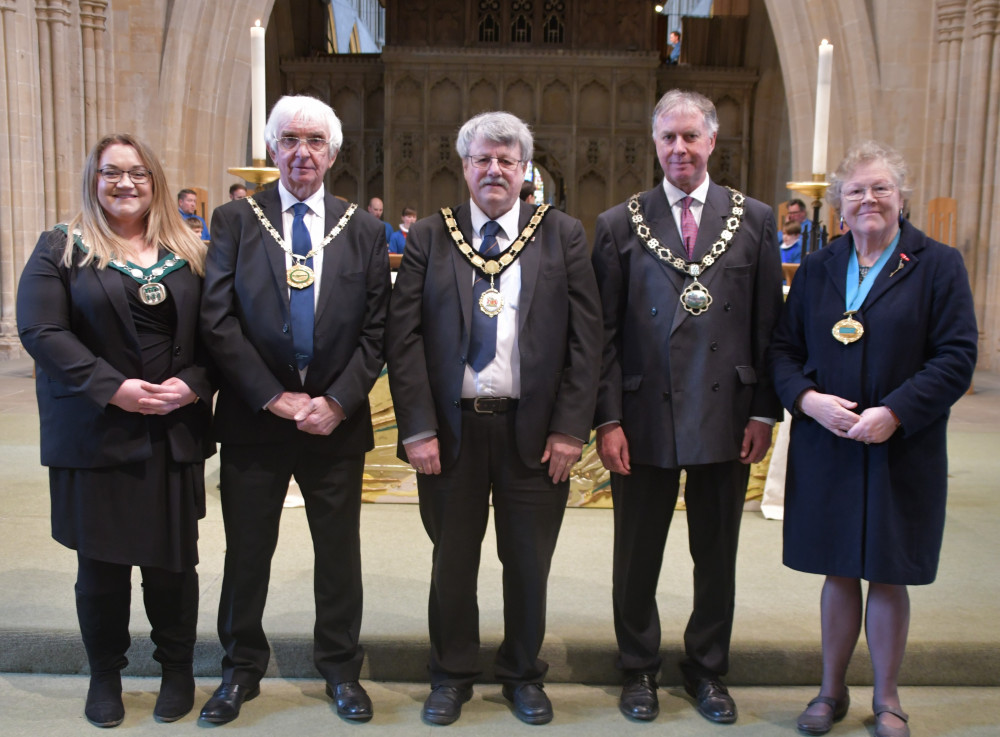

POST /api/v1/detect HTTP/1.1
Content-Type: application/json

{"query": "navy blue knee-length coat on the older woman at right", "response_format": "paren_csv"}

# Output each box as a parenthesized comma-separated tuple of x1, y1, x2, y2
(770, 223, 977, 585)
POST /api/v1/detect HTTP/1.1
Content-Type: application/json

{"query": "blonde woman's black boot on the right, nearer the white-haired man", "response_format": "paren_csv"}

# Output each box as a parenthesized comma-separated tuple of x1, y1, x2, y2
(142, 570, 198, 722)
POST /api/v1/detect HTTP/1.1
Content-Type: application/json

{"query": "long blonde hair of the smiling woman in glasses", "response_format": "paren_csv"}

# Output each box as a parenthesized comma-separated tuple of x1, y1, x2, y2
(63, 133, 206, 276)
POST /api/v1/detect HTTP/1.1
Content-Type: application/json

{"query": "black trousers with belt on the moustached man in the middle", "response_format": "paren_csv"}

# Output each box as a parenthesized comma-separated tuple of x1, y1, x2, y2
(417, 410, 569, 687)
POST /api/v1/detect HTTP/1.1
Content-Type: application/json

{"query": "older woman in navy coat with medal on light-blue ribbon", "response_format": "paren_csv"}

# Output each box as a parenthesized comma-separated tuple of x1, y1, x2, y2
(771, 141, 977, 737)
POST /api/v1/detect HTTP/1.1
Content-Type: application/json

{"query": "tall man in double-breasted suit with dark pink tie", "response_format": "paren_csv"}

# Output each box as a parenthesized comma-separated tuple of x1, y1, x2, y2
(593, 90, 781, 723)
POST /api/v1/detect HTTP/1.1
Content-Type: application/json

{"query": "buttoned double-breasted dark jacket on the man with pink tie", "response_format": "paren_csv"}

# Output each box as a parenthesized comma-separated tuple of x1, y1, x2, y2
(593, 183, 782, 468)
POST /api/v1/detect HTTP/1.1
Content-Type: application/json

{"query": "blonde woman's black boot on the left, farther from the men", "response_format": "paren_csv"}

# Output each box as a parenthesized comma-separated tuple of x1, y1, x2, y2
(76, 586, 132, 727)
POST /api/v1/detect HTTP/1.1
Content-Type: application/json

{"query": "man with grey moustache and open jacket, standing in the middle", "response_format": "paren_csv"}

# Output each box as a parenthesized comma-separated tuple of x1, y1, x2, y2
(386, 113, 600, 724)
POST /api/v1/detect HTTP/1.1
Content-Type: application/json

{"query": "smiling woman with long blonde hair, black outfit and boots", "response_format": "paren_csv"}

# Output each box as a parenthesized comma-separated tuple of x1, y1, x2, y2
(17, 134, 215, 727)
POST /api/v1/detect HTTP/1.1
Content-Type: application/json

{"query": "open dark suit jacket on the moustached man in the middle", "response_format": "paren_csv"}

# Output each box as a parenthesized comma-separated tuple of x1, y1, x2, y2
(386, 202, 600, 469)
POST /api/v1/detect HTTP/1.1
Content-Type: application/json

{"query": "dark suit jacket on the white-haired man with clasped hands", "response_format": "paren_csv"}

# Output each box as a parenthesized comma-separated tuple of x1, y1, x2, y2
(201, 188, 389, 454)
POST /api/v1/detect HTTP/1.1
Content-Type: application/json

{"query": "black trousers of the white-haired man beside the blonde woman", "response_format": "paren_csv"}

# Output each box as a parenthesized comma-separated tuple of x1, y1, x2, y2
(218, 436, 364, 686)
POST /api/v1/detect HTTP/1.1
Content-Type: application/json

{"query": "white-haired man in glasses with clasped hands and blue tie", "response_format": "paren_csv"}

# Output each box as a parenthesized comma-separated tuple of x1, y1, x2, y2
(201, 97, 389, 723)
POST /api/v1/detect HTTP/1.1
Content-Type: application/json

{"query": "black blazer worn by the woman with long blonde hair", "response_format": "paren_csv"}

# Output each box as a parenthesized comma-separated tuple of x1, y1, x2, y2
(17, 230, 215, 468)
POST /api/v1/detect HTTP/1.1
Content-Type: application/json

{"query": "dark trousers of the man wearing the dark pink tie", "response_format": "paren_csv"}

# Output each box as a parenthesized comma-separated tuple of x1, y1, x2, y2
(611, 461, 750, 679)
